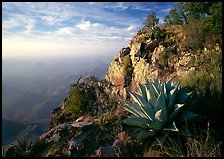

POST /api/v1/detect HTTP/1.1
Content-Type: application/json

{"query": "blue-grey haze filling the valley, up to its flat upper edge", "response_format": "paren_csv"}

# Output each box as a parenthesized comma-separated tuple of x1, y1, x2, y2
(2, 57, 110, 144)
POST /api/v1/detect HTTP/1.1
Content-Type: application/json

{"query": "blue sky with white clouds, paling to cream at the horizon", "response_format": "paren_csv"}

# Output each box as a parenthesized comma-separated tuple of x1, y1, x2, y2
(2, 2, 176, 59)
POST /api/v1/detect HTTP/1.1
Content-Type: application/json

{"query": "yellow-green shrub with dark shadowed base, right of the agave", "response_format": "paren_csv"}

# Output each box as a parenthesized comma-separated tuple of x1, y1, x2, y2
(181, 71, 222, 127)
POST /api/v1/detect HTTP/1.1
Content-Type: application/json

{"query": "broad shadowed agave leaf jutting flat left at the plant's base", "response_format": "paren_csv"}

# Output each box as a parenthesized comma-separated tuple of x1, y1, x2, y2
(123, 117, 150, 128)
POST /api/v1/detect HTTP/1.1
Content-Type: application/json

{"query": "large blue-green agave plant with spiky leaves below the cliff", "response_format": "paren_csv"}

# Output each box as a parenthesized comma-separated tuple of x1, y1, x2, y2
(123, 78, 198, 144)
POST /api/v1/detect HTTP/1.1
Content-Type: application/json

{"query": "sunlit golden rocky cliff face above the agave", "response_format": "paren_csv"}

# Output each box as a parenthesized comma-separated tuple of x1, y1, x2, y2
(105, 25, 197, 99)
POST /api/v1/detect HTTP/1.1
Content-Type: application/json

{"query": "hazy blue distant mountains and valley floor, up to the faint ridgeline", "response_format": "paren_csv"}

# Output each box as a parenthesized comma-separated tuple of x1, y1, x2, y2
(2, 61, 108, 145)
